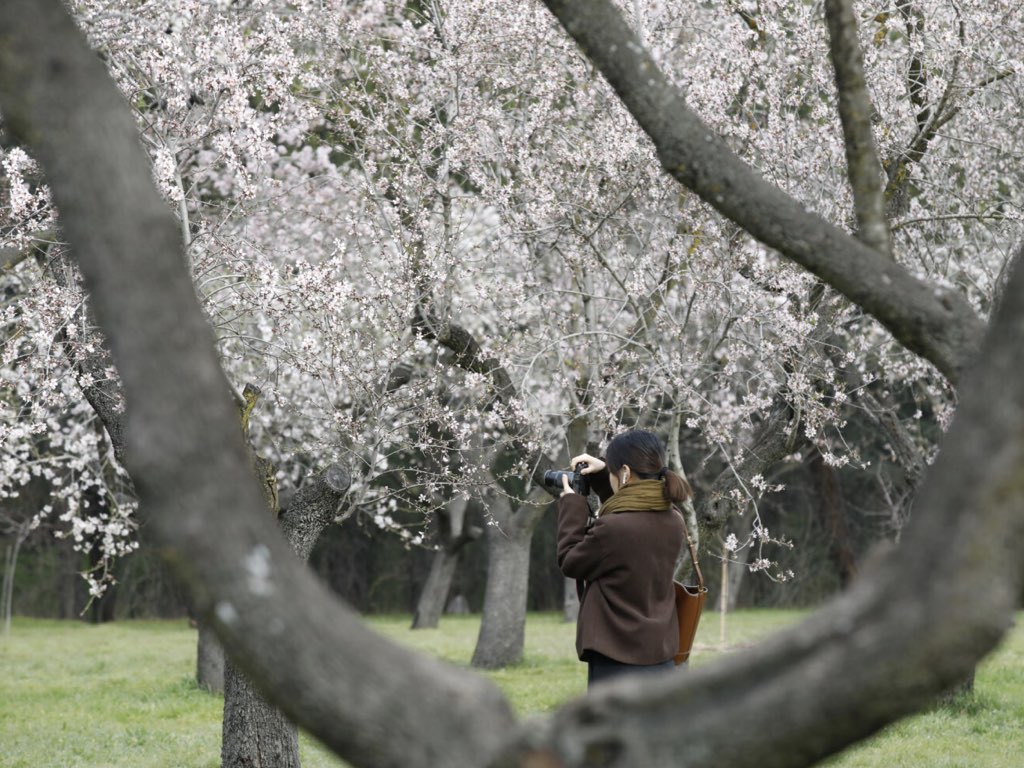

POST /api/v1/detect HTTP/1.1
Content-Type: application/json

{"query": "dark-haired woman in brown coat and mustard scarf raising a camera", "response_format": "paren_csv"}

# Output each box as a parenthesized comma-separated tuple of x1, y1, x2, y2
(558, 430, 692, 687)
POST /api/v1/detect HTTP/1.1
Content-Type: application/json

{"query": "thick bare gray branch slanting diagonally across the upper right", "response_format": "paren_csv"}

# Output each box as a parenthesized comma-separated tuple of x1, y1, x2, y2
(545, 0, 984, 384)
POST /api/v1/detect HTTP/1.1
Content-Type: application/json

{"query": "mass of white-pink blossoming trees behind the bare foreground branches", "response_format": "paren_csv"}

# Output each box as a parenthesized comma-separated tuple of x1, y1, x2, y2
(0, 0, 1021, 630)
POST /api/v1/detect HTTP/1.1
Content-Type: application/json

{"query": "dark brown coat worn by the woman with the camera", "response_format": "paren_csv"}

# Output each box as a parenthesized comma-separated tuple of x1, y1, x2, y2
(558, 472, 685, 665)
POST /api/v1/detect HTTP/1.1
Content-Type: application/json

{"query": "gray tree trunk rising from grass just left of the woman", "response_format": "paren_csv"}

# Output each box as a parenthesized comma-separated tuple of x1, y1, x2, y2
(472, 496, 537, 670)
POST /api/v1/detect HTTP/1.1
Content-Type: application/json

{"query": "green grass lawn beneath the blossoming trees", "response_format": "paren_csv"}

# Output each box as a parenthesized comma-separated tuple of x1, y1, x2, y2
(0, 610, 1024, 768)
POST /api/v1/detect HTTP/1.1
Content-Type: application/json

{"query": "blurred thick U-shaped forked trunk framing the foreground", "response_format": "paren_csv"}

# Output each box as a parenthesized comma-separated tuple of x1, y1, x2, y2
(6, 0, 1024, 768)
